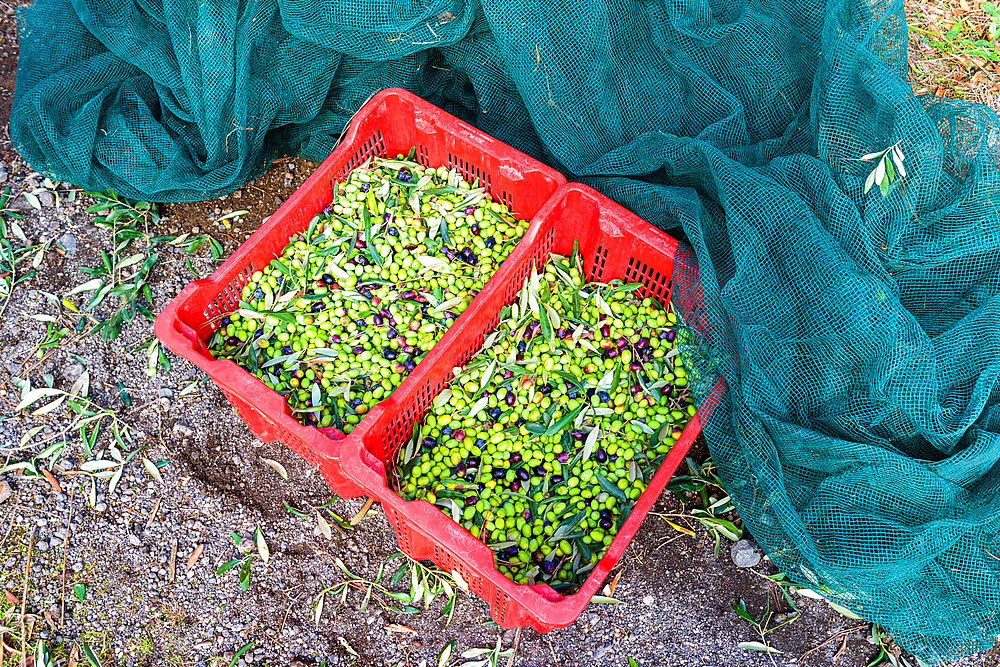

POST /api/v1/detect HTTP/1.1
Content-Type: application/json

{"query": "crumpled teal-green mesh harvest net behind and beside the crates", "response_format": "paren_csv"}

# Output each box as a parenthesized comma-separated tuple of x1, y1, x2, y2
(10, 0, 1000, 662)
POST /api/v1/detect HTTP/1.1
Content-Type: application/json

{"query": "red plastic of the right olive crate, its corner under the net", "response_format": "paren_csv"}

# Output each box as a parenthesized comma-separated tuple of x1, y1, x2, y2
(341, 183, 725, 632)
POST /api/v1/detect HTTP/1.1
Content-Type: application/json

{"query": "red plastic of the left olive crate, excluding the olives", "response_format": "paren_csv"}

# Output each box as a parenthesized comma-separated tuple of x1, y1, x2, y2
(155, 88, 566, 496)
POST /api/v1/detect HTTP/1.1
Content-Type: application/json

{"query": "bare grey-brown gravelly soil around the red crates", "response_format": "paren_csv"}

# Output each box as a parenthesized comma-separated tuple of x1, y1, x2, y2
(0, 5, 1000, 667)
